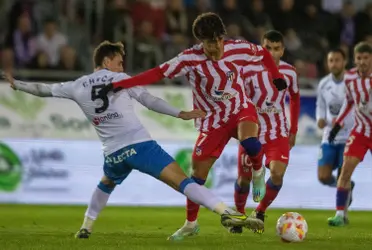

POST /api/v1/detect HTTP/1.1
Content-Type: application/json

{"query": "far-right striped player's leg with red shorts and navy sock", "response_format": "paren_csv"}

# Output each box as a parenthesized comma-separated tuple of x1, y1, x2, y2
(328, 132, 370, 226)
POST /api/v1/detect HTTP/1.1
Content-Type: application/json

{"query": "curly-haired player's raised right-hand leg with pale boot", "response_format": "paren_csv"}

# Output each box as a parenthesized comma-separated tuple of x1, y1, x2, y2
(237, 104, 266, 202)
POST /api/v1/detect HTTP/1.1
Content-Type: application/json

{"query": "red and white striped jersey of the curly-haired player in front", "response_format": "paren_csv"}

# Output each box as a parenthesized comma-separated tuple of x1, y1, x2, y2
(160, 40, 263, 132)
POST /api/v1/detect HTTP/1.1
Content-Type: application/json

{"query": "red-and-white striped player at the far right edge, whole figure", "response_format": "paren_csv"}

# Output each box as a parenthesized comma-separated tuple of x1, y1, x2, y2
(328, 42, 372, 226)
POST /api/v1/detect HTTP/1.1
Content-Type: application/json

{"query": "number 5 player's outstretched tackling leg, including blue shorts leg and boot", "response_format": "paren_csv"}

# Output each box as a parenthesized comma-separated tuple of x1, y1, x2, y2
(125, 141, 262, 238)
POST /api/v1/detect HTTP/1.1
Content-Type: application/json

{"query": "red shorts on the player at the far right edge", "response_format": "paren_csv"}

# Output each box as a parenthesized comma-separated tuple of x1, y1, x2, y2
(344, 130, 372, 161)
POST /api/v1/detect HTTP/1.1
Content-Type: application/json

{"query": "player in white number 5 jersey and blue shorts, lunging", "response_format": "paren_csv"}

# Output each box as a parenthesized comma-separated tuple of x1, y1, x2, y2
(5, 42, 260, 238)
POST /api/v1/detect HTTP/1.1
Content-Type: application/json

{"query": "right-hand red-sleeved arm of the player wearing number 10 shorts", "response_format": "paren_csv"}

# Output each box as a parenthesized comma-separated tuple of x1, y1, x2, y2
(289, 70, 301, 148)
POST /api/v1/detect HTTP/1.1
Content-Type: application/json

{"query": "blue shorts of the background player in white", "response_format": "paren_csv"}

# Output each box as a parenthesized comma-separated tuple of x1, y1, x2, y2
(318, 143, 345, 170)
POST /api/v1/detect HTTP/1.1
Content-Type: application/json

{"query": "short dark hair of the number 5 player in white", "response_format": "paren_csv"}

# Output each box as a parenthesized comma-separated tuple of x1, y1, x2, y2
(93, 41, 125, 68)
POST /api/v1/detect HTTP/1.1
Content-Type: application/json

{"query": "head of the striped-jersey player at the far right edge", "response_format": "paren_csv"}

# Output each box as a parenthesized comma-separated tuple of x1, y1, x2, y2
(354, 42, 372, 74)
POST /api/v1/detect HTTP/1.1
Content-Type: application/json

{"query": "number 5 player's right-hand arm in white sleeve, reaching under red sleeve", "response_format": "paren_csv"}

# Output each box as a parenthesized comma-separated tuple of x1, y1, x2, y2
(128, 87, 205, 120)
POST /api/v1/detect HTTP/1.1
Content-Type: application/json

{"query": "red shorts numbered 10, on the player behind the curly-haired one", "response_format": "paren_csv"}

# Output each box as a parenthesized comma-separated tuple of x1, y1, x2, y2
(238, 137, 290, 177)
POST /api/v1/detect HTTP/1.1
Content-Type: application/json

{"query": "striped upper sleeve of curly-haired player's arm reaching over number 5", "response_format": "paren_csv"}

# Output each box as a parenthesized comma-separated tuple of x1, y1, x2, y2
(160, 52, 196, 79)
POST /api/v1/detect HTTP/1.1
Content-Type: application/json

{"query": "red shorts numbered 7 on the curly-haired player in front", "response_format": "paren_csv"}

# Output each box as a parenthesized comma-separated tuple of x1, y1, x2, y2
(192, 103, 258, 161)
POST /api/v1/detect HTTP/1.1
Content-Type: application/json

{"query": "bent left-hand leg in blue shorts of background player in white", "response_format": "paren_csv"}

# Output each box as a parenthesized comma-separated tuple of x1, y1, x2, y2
(318, 143, 338, 187)
